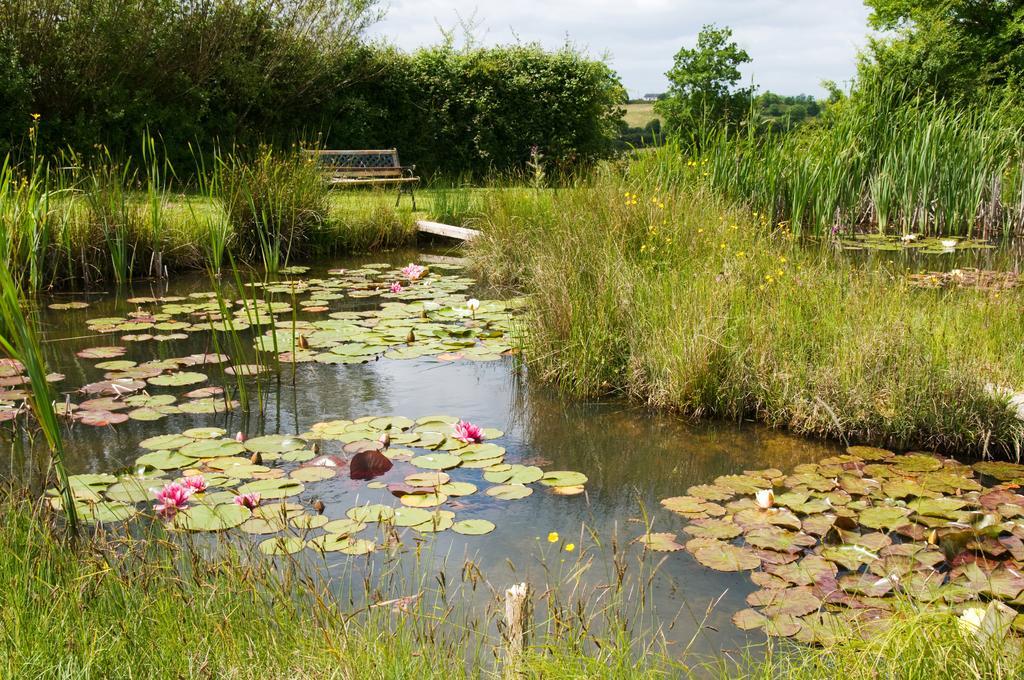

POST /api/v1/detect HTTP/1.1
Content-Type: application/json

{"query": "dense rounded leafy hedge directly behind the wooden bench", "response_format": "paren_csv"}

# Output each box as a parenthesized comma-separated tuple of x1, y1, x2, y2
(325, 45, 626, 178)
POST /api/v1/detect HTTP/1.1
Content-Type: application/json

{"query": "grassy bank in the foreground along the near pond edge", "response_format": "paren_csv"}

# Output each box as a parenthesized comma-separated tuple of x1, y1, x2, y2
(0, 495, 1024, 680)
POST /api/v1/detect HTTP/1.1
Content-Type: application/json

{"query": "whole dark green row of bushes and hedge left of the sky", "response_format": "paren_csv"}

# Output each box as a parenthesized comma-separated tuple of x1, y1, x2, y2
(0, 0, 626, 176)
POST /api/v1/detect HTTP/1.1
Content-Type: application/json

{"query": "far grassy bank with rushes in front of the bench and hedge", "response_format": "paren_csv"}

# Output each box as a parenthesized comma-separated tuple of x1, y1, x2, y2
(0, 144, 517, 290)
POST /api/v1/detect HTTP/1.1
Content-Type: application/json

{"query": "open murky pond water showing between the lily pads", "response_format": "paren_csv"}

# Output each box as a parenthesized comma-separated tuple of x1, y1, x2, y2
(4, 251, 837, 652)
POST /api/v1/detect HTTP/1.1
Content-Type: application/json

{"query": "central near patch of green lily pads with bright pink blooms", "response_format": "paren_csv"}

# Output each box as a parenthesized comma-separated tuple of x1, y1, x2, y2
(47, 416, 589, 555)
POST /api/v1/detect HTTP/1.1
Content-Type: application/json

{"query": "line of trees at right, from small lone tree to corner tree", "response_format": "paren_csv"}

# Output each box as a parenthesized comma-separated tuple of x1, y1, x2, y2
(654, 0, 1024, 139)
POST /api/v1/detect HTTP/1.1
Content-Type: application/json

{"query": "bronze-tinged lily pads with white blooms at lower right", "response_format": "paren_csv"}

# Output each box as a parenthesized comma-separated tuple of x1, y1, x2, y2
(655, 447, 1024, 644)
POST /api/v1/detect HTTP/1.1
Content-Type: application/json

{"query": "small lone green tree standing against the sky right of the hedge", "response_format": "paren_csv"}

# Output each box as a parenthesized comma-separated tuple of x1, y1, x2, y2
(654, 24, 754, 130)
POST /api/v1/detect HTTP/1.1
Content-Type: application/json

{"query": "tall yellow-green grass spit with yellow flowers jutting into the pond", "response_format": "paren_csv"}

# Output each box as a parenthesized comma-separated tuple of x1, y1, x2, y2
(473, 170, 1024, 454)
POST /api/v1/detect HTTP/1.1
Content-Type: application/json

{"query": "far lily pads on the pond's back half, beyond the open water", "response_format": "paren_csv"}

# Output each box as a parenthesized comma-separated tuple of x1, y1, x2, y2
(0, 263, 524, 428)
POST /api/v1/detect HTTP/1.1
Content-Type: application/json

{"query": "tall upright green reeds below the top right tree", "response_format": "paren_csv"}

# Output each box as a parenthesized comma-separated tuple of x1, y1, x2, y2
(636, 85, 1024, 238)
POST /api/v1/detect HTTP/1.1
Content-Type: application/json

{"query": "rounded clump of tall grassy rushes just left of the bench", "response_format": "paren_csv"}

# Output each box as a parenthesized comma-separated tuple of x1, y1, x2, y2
(218, 147, 329, 273)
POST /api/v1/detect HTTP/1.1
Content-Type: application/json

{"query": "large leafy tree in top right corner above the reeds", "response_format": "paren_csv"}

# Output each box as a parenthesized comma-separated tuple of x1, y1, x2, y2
(861, 0, 1024, 96)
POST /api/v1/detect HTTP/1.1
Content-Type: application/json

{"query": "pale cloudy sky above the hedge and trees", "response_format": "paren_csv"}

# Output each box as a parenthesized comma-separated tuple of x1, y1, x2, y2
(371, 0, 867, 96)
